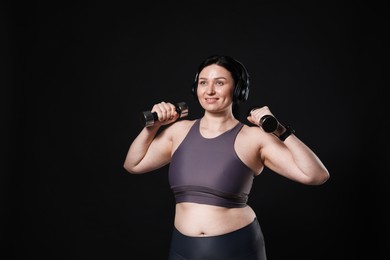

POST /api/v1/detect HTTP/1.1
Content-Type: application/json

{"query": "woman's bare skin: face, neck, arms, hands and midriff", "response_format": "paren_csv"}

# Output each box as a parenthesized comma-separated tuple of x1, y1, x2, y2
(124, 64, 329, 236)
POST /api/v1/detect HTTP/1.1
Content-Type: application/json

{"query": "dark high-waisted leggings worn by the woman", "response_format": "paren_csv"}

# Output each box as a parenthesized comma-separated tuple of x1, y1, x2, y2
(169, 218, 267, 260)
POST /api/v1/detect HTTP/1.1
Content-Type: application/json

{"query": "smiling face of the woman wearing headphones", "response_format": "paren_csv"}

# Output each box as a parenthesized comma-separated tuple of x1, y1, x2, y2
(197, 64, 235, 112)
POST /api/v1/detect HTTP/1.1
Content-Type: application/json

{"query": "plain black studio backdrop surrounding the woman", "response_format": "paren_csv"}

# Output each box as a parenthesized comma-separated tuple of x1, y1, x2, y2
(0, 1, 389, 260)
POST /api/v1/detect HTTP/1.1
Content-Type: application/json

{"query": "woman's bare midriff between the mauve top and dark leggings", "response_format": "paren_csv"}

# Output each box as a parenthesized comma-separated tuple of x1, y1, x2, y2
(175, 202, 256, 237)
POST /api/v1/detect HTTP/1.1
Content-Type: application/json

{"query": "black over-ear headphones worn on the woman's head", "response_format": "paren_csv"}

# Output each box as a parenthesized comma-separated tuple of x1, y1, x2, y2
(192, 56, 249, 104)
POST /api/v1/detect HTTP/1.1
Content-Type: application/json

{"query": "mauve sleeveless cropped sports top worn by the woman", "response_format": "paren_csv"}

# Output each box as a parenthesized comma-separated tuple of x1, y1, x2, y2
(169, 120, 255, 208)
